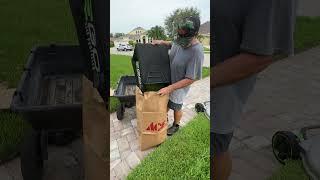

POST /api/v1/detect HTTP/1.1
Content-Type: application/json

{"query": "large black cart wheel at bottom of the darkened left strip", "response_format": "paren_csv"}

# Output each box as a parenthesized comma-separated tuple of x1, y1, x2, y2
(20, 130, 43, 180)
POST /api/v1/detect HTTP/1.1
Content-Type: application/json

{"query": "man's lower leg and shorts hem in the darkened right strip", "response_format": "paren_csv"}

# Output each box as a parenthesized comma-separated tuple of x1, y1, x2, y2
(210, 133, 233, 180)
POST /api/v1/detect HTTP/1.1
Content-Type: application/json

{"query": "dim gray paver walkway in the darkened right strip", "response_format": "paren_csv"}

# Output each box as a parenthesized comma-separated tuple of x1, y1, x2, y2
(230, 47, 320, 180)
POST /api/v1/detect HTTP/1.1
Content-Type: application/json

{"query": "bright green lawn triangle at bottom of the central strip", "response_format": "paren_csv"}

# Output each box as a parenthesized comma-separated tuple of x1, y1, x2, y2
(127, 114, 210, 180)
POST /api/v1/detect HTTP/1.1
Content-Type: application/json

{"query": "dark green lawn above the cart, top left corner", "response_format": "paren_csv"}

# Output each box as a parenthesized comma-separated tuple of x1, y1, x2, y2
(0, 0, 77, 87)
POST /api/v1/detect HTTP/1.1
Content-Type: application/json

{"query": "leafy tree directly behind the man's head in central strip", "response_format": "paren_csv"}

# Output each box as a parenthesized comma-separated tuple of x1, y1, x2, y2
(164, 7, 200, 39)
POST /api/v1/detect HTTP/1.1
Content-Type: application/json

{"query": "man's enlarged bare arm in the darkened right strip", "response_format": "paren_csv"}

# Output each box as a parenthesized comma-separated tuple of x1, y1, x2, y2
(210, 53, 273, 88)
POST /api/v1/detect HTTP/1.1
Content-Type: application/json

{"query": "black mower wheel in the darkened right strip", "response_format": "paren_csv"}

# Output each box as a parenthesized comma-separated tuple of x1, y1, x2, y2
(272, 131, 301, 164)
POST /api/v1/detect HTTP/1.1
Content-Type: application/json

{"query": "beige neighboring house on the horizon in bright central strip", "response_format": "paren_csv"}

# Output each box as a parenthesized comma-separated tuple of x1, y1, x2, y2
(110, 27, 152, 47)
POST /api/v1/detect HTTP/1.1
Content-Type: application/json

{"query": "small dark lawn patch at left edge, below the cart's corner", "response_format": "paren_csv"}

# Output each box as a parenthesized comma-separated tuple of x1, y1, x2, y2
(0, 112, 29, 161)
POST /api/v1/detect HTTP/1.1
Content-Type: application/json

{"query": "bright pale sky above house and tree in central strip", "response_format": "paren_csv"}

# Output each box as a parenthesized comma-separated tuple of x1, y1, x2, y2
(110, 0, 210, 34)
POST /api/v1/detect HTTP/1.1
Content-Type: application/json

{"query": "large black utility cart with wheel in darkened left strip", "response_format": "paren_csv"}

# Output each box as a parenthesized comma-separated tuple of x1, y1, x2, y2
(11, 45, 84, 180)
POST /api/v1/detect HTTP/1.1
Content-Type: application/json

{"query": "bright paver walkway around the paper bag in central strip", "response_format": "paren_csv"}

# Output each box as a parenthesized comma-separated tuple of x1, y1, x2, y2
(110, 77, 210, 180)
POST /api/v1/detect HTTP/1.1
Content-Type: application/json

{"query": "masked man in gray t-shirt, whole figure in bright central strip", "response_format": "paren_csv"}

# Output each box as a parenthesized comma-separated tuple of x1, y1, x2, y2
(152, 17, 204, 136)
